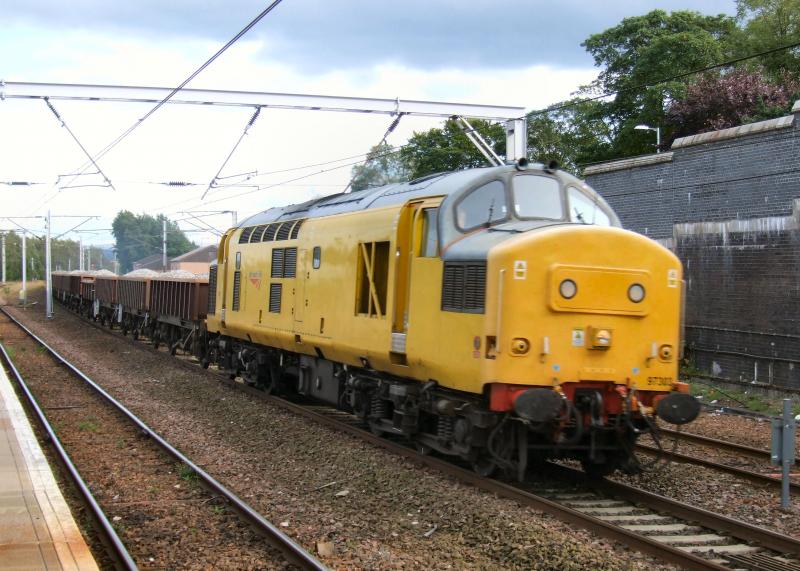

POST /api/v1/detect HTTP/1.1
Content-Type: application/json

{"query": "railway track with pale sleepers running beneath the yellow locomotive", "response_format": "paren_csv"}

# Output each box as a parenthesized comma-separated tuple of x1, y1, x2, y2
(10, 302, 800, 571)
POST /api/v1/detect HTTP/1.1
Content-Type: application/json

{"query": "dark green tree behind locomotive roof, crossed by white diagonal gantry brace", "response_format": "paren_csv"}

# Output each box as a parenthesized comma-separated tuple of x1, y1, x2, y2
(400, 119, 506, 178)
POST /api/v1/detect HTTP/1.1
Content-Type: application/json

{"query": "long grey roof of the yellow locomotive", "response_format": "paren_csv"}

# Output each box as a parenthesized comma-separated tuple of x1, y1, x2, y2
(238, 164, 578, 228)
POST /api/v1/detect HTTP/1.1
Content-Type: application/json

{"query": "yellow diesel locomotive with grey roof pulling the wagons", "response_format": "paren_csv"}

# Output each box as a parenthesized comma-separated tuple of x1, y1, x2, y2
(203, 161, 699, 478)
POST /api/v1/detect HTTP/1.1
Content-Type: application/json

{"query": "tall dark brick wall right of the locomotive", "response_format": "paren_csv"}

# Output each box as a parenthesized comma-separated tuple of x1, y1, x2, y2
(586, 105, 800, 388)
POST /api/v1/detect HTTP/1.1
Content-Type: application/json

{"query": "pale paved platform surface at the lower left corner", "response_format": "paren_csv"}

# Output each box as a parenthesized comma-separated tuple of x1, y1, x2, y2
(0, 358, 97, 571)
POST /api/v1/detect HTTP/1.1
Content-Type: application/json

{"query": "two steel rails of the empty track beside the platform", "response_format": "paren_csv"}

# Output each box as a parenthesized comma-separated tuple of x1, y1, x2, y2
(0, 307, 327, 571)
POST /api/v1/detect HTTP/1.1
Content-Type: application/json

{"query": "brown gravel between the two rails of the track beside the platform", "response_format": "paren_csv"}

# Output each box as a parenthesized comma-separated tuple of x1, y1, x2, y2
(0, 317, 287, 569)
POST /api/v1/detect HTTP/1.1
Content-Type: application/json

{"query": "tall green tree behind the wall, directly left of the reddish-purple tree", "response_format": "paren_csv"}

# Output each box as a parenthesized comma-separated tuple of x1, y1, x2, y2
(580, 10, 740, 160)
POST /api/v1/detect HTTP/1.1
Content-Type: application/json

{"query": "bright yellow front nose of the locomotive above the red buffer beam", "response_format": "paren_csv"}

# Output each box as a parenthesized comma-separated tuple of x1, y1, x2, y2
(482, 225, 681, 396)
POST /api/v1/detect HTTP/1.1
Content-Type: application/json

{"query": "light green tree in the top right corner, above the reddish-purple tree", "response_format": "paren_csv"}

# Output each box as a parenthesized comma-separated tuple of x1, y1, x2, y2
(736, 0, 800, 84)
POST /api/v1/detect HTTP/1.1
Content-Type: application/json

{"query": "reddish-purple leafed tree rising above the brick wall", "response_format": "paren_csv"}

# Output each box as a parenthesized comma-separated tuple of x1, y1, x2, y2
(666, 69, 800, 138)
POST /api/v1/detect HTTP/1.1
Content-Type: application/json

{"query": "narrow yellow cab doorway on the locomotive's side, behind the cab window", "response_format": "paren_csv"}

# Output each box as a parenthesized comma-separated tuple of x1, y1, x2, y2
(390, 196, 442, 358)
